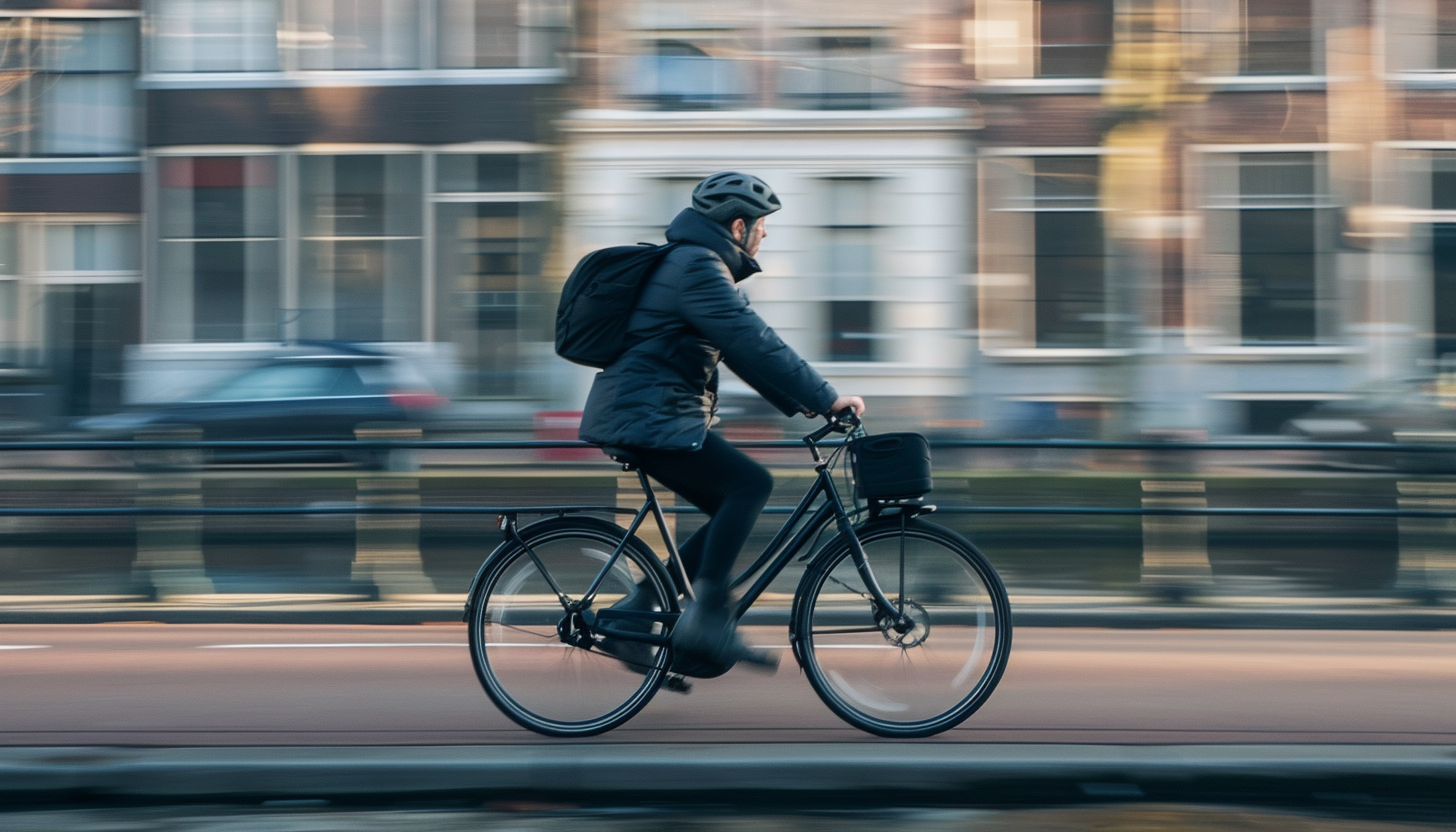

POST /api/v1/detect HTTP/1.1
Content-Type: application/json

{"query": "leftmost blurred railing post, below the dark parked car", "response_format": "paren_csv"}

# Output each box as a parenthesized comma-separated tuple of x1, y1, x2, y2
(132, 428, 215, 600)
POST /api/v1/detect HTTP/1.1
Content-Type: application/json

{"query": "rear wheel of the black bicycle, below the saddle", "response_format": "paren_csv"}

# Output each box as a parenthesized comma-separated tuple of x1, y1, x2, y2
(467, 517, 677, 737)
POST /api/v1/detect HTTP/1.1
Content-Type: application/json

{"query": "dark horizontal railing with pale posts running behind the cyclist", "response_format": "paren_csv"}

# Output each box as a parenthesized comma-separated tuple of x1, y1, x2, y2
(0, 436, 1456, 600)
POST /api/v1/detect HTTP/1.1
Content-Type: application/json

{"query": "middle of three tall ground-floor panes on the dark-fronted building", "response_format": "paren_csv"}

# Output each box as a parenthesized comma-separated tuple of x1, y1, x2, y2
(298, 154, 422, 341)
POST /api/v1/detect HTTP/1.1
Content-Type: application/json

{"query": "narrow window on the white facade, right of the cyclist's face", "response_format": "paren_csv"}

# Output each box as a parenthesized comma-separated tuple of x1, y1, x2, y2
(820, 179, 881, 361)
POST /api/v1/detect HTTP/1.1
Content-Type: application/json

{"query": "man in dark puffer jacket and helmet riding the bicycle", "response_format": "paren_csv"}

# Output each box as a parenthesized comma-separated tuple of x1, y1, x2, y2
(581, 172, 865, 669)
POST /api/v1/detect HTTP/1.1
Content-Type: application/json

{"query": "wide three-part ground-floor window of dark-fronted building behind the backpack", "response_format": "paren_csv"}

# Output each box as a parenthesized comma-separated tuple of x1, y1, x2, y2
(150, 153, 553, 371)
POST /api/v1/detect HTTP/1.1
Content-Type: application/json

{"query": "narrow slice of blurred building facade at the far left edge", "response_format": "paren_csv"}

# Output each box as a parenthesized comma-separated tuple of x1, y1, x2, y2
(0, 1, 143, 421)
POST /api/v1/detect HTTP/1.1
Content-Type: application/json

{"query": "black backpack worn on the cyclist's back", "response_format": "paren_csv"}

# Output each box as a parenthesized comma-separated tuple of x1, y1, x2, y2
(556, 243, 677, 369)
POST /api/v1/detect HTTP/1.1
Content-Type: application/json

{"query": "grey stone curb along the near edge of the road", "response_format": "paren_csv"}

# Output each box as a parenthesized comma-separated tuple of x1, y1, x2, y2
(0, 742, 1456, 806)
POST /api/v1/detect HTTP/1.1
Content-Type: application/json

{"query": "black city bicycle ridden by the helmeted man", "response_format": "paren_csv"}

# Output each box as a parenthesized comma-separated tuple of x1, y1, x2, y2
(464, 411, 1012, 737)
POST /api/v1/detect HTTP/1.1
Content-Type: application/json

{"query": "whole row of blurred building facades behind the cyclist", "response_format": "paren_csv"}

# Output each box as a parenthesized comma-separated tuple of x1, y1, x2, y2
(8, 0, 1456, 436)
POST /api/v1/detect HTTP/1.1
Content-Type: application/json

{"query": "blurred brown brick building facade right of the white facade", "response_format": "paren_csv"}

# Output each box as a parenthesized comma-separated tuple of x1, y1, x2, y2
(967, 0, 1456, 434)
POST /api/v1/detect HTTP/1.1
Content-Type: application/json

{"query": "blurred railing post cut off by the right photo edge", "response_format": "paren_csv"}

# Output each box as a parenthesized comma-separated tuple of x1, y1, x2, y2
(1395, 479, 1456, 600)
